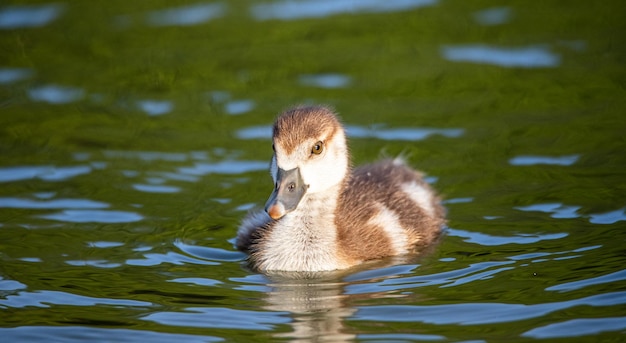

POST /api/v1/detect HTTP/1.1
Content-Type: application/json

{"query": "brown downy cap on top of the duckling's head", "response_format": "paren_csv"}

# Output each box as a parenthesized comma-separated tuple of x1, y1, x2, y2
(272, 106, 341, 154)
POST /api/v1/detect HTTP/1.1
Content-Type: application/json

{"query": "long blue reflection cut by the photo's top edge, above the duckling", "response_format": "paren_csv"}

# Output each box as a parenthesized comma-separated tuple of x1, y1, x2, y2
(251, 0, 437, 20)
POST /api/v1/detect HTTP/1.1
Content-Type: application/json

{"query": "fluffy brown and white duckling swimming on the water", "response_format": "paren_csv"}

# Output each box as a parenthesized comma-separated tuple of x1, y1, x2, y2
(236, 106, 445, 272)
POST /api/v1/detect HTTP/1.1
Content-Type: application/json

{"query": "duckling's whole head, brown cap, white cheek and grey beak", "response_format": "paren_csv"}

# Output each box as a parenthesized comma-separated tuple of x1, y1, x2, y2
(265, 106, 350, 219)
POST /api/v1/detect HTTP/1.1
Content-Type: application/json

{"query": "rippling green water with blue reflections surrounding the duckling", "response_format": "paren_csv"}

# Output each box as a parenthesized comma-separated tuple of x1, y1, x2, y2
(0, 0, 626, 342)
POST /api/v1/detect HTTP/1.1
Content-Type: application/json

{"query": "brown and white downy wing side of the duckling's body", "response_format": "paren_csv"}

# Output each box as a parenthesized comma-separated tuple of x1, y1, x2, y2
(335, 159, 444, 260)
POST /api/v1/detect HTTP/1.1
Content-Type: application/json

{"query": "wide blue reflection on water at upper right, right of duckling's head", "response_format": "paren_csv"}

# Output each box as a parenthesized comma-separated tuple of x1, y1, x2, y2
(441, 44, 561, 68)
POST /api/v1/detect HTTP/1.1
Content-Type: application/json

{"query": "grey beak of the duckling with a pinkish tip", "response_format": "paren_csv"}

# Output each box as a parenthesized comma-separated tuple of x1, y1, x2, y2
(265, 168, 308, 219)
